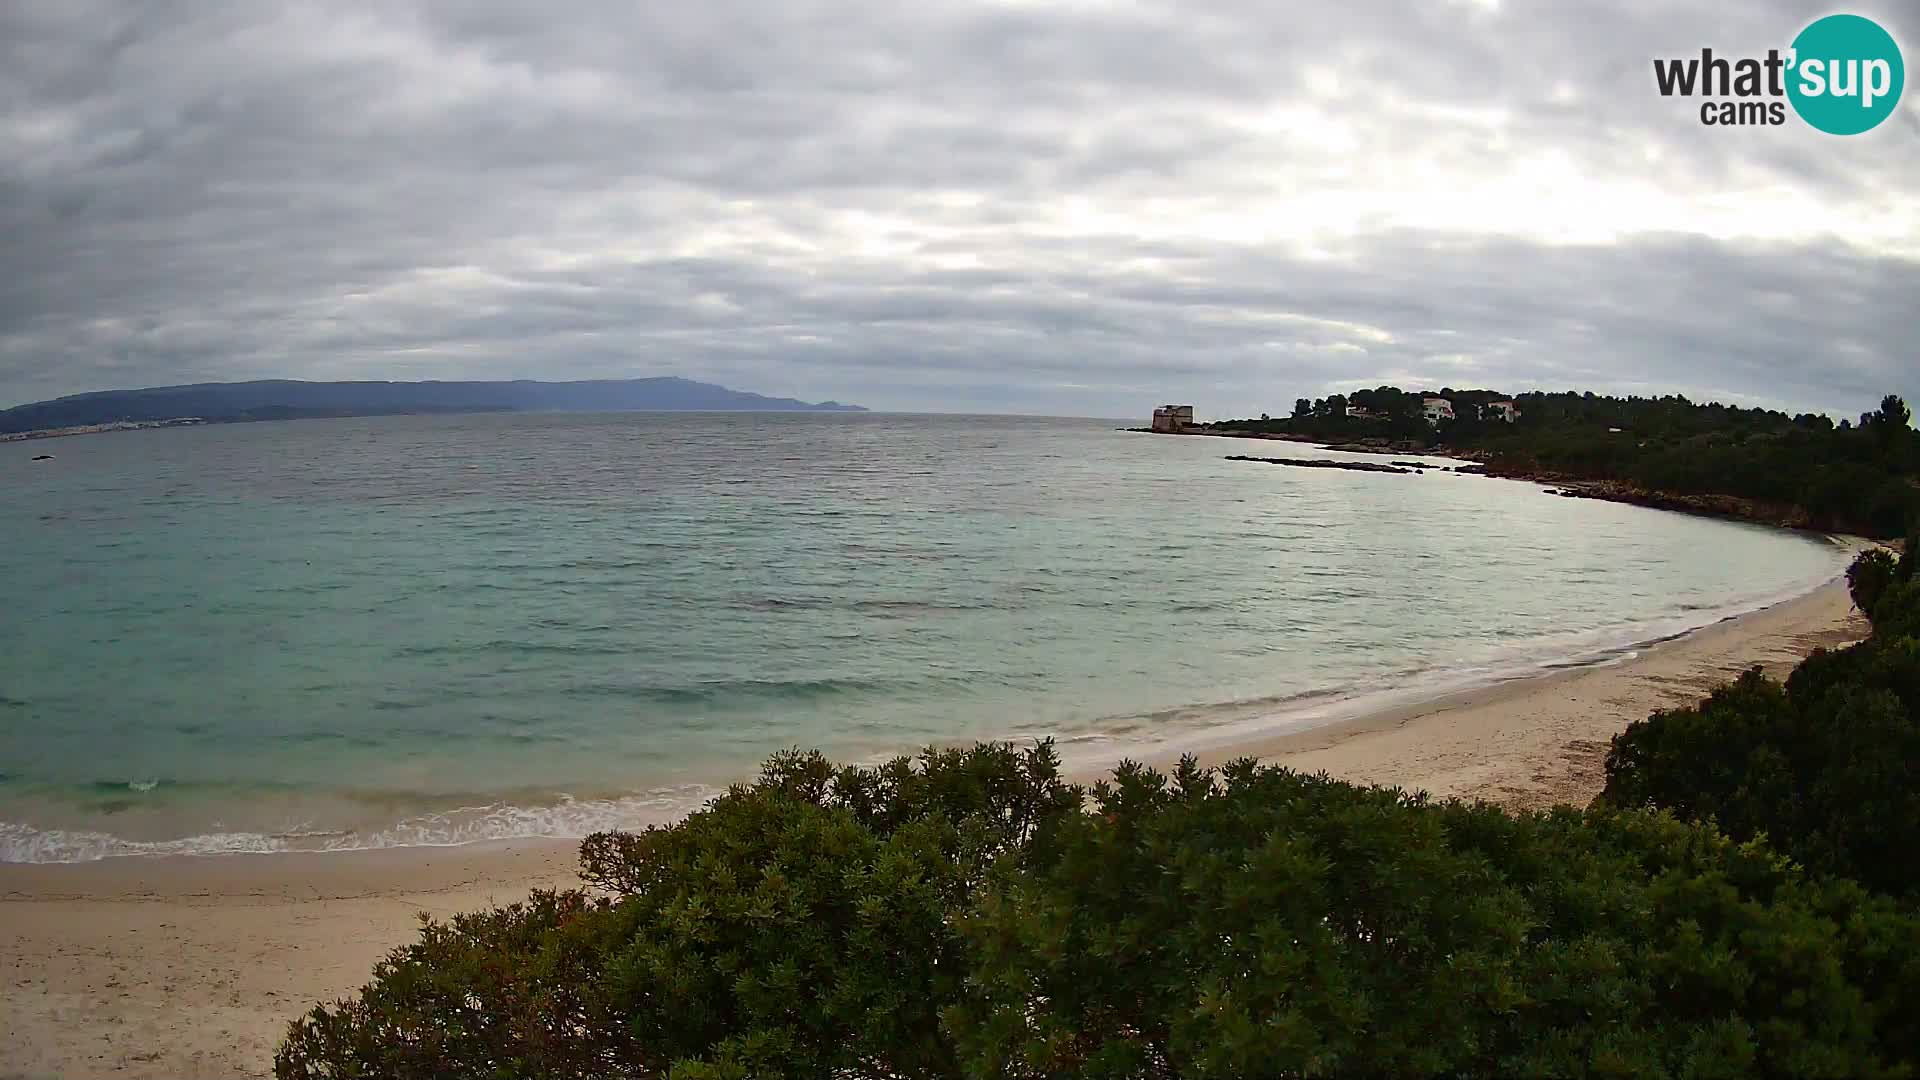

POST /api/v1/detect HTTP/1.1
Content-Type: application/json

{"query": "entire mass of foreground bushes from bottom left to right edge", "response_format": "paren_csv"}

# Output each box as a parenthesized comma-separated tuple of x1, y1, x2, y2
(275, 544, 1920, 1080)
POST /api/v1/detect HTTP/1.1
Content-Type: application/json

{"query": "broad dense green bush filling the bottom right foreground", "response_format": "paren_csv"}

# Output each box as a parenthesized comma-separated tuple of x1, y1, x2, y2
(950, 763, 1920, 1076)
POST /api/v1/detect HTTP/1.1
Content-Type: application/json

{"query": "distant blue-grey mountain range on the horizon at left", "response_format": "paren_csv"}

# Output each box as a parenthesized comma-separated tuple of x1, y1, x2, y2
(0, 379, 866, 432)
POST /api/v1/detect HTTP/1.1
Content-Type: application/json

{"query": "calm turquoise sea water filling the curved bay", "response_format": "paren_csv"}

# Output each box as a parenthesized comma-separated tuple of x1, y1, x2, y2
(0, 413, 1843, 861)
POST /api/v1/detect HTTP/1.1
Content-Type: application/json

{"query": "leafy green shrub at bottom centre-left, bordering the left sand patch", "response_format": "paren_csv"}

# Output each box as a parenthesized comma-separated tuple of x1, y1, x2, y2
(275, 744, 1081, 1080)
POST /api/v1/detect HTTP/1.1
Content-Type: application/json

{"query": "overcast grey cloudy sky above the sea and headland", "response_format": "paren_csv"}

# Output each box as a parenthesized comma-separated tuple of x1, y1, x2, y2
(0, 0, 1920, 417)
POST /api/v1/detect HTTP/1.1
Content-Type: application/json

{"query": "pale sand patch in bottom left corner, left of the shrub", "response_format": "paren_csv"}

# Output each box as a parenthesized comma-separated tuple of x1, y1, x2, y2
(0, 842, 578, 1080)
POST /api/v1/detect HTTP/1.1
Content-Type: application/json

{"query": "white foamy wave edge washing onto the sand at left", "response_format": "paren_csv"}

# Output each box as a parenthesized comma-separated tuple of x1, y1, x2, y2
(0, 784, 718, 863)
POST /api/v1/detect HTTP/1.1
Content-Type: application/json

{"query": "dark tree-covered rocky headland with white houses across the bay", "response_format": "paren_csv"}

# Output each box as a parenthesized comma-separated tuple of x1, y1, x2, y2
(1202, 386, 1920, 538)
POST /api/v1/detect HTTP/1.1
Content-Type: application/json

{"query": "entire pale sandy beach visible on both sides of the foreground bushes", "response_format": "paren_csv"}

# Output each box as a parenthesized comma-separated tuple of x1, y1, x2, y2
(0, 584, 1866, 1080)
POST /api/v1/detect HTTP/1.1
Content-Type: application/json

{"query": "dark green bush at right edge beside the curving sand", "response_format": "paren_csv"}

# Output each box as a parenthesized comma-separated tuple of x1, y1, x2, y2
(1601, 542, 1920, 897)
